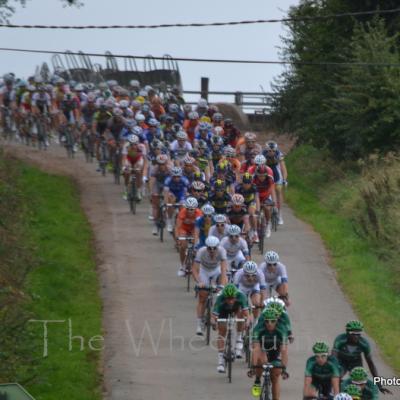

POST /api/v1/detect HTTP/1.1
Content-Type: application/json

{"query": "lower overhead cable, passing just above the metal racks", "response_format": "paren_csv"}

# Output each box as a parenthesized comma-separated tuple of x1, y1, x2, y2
(0, 47, 400, 67)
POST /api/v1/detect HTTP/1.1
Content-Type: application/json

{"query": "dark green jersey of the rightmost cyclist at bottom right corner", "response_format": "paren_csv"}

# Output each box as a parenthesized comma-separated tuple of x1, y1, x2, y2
(333, 333, 371, 372)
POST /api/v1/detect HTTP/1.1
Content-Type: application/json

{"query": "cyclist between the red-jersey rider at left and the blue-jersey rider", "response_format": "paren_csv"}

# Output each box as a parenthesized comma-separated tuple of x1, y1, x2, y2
(150, 154, 171, 235)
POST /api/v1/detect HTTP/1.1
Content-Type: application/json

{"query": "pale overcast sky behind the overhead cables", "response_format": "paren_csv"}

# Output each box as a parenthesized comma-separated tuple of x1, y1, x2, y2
(0, 0, 298, 98)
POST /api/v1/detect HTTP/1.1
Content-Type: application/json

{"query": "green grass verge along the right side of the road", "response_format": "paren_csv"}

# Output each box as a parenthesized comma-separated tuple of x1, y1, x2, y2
(286, 146, 400, 373)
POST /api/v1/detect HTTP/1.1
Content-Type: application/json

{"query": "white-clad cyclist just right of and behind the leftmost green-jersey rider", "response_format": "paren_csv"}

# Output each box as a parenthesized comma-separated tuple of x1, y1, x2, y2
(233, 261, 265, 319)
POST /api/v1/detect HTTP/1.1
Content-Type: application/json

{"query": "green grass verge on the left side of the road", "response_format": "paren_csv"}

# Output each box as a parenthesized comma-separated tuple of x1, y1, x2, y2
(18, 165, 102, 400)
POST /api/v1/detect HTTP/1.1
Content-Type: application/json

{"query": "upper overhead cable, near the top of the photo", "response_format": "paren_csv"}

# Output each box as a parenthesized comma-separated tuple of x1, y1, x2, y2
(0, 8, 400, 29)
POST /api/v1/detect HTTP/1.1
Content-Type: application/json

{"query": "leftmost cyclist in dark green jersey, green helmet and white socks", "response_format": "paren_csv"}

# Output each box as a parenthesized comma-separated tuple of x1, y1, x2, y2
(211, 284, 249, 373)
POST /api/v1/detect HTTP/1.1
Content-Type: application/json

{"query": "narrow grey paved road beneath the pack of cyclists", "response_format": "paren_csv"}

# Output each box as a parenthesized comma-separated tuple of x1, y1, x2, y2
(5, 146, 399, 400)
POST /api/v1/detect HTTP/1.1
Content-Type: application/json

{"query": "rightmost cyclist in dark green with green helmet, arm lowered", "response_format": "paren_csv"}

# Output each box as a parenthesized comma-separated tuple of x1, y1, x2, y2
(332, 320, 388, 393)
